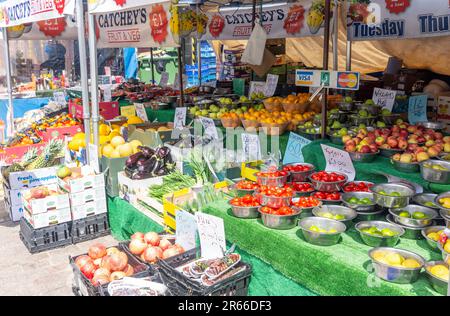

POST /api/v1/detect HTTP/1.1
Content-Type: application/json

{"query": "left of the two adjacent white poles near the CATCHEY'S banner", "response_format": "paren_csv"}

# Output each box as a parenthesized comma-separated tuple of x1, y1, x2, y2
(76, 0, 91, 157)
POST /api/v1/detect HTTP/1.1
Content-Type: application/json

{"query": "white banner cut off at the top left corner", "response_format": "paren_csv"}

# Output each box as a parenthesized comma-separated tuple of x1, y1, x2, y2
(0, 0, 76, 27)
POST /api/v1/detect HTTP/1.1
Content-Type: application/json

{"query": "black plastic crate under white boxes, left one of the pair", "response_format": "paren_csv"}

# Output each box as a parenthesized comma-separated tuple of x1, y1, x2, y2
(19, 217, 72, 253)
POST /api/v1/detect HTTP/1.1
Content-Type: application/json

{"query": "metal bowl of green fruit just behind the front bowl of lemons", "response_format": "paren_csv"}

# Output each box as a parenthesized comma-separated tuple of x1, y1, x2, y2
(355, 221, 405, 247)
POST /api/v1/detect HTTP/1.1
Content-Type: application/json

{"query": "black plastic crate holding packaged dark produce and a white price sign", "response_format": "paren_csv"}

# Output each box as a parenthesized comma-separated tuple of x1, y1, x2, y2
(157, 249, 252, 296)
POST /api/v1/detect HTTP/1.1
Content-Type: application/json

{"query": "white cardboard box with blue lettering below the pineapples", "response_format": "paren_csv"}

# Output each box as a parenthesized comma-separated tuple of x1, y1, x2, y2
(5, 167, 58, 190)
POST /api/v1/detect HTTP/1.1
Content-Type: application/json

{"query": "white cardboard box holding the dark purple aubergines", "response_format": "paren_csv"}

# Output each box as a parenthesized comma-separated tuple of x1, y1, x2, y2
(118, 171, 163, 205)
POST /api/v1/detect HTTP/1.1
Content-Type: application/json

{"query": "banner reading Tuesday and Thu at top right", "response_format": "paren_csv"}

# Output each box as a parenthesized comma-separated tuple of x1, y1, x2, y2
(347, 0, 450, 41)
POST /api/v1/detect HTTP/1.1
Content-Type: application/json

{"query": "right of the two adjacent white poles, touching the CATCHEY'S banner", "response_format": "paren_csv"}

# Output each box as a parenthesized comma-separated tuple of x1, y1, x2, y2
(89, 14, 100, 165)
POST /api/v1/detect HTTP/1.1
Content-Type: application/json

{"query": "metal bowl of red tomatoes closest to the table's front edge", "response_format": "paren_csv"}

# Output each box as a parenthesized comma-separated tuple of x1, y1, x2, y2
(258, 206, 301, 230)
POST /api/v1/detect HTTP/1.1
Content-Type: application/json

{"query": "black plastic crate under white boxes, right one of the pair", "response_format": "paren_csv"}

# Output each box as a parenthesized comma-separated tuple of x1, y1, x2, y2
(71, 213, 111, 244)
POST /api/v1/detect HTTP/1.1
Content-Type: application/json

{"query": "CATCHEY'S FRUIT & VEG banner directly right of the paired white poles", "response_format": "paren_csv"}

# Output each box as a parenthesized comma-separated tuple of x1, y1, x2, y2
(95, 1, 178, 48)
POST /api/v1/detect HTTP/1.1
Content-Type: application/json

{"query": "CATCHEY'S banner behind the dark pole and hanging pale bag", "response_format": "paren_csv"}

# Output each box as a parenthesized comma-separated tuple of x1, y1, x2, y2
(195, 0, 332, 40)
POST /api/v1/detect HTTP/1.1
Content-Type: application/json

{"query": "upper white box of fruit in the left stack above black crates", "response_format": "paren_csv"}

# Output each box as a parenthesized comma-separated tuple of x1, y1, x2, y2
(22, 184, 70, 215)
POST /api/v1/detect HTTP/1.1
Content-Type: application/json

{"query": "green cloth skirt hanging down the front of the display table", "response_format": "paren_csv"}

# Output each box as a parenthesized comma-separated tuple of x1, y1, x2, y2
(108, 198, 316, 296)
